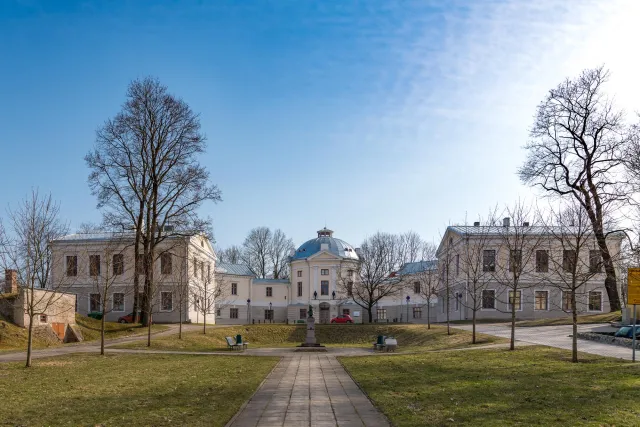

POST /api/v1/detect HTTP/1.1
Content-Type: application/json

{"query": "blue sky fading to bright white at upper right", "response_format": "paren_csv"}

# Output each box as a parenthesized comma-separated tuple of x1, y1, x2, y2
(0, 0, 640, 246)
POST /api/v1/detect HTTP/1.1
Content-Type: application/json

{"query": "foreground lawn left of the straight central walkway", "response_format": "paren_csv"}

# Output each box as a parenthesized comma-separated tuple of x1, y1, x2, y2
(0, 355, 278, 426)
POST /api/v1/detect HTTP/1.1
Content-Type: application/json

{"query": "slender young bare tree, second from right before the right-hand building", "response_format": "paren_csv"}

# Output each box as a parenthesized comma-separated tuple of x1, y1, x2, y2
(492, 200, 546, 350)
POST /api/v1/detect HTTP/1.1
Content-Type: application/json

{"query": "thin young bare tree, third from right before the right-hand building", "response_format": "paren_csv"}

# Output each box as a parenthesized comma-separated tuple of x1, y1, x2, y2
(459, 215, 495, 344)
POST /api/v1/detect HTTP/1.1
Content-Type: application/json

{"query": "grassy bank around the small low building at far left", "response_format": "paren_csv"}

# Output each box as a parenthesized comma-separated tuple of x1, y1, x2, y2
(0, 314, 168, 352)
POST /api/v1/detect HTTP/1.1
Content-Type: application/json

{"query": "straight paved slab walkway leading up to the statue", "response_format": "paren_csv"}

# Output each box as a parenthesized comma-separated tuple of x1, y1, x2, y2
(227, 353, 389, 427)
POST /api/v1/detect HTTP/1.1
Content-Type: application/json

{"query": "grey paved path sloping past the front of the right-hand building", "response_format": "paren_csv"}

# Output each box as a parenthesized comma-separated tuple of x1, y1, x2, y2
(456, 324, 640, 360)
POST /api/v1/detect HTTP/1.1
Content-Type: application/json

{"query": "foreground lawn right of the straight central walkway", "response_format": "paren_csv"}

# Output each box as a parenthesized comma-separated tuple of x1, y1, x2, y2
(340, 347, 640, 426)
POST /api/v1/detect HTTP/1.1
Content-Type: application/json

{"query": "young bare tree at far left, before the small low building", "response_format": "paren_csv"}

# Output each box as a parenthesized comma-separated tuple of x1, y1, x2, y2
(0, 190, 69, 367)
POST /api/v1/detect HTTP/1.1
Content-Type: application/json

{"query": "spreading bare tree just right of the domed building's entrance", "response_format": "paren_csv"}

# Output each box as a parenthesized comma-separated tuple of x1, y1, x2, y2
(336, 232, 402, 323)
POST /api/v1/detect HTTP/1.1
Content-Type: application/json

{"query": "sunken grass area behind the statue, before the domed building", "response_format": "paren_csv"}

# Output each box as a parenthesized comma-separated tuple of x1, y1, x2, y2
(118, 324, 502, 352)
